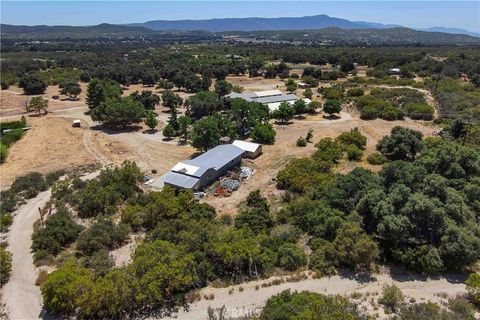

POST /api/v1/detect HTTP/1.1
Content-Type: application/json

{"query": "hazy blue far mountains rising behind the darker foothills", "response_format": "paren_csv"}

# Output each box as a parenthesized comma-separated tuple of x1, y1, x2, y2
(130, 14, 480, 37)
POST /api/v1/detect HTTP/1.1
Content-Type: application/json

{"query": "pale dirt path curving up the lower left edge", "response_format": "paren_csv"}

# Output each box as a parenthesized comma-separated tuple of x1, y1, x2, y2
(2, 190, 51, 320)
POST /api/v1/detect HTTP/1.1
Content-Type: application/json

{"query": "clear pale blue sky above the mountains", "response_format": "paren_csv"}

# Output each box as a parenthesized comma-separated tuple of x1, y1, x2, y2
(0, 0, 480, 33)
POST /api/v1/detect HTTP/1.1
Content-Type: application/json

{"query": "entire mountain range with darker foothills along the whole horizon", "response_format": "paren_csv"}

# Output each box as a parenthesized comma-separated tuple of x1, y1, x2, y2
(0, 15, 480, 45)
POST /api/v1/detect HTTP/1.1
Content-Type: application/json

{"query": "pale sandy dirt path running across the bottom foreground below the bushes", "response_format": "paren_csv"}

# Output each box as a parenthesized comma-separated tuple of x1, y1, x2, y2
(165, 273, 466, 320)
